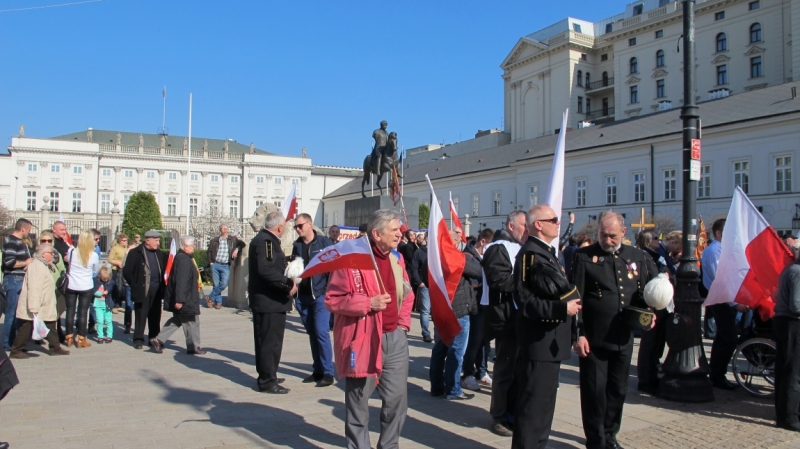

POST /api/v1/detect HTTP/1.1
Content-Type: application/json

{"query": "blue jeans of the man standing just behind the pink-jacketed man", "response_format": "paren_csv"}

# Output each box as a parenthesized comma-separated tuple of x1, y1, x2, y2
(295, 295, 333, 379)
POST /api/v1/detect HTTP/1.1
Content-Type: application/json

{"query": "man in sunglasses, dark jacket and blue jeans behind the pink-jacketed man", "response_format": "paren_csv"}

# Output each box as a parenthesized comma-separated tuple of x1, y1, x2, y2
(292, 214, 333, 387)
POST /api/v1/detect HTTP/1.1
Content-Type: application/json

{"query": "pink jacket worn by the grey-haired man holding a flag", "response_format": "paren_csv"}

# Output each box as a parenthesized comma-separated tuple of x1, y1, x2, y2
(325, 252, 414, 382)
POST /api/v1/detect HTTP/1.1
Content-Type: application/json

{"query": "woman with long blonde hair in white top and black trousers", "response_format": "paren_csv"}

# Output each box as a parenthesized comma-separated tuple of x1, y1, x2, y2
(65, 231, 100, 348)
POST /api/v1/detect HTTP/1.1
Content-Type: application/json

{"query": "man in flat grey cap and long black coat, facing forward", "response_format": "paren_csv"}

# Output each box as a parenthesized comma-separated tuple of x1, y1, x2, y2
(122, 229, 166, 349)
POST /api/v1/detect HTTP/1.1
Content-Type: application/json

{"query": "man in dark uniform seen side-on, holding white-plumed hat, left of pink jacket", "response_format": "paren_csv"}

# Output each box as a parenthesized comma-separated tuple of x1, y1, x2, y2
(247, 211, 297, 394)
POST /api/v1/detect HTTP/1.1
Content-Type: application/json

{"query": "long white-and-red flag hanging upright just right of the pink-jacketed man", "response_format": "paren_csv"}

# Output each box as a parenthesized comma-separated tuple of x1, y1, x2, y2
(425, 175, 466, 346)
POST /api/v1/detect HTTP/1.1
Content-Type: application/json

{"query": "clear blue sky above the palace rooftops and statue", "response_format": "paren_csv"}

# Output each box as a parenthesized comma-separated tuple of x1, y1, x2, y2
(0, 0, 629, 167)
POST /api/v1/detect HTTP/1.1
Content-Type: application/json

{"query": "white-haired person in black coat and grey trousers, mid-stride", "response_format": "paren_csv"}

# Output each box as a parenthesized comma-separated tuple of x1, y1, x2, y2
(150, 235, 206, 355)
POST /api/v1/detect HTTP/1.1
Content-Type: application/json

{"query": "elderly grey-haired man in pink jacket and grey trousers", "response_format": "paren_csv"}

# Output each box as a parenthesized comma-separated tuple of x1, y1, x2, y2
(325, 209, 414, 448)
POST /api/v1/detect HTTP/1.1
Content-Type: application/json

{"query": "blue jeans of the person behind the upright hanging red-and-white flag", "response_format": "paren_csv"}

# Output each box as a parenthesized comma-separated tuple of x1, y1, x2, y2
(430, 315, 469, 396)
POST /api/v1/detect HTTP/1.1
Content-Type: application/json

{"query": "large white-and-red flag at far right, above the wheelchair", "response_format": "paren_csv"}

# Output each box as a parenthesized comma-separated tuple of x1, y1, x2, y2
(703, 187, 794, 320)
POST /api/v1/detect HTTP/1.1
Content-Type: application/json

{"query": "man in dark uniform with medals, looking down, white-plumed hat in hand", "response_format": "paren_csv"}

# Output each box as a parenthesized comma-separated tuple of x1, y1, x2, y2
(572, 212, 656, 449)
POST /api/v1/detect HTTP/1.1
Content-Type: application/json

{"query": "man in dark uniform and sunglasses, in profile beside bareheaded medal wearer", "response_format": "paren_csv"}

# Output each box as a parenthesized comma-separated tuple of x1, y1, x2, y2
(511, 205, 581, 448)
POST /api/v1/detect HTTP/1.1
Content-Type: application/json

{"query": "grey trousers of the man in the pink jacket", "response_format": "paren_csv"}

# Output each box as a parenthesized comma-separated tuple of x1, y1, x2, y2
(344, 327, 408, 449)
